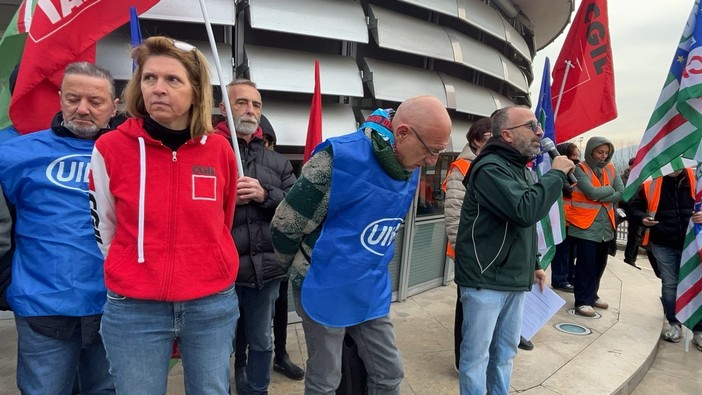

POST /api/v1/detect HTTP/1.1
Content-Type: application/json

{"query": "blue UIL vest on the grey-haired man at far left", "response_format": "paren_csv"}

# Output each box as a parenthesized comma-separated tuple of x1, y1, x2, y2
(0, 130, 106, 317)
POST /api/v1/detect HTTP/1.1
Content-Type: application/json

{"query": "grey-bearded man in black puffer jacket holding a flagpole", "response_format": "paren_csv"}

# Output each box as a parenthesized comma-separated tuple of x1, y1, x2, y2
(217, 79, 304, 395)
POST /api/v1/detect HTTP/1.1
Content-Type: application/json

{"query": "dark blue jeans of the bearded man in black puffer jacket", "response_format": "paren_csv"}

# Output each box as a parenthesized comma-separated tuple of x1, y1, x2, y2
(236, 280, 280, 395)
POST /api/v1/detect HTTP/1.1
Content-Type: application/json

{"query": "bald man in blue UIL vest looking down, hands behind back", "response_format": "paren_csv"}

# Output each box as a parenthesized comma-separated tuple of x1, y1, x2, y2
(271, 96, 451, 394)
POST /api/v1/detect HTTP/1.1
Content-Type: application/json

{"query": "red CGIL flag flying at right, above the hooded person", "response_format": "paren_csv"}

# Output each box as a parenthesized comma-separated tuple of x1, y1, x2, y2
(551, 0, 617, 141)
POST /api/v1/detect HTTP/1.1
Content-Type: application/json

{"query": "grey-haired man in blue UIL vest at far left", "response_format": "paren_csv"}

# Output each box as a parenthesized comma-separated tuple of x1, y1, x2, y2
(0, 62, 117, 394)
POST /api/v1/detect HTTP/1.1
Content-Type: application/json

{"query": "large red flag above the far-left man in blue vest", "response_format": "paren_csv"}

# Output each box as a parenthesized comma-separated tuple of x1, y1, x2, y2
(10, 0, 158, 134)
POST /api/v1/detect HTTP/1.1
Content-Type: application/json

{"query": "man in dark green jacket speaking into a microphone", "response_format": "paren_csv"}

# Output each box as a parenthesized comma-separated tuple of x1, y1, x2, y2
(455, 106, 574, 395)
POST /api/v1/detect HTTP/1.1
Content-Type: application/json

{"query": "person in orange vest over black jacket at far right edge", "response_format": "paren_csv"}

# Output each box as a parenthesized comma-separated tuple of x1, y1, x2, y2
(629, 168, 702, 351)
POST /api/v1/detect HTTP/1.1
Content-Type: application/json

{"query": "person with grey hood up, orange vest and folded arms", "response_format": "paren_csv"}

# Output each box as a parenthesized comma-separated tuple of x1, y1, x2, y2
(566, 137, 624, 317)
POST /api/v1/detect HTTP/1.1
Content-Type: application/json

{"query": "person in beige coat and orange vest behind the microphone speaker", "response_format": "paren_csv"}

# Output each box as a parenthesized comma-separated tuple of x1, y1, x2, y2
(441, 118, 492, 370)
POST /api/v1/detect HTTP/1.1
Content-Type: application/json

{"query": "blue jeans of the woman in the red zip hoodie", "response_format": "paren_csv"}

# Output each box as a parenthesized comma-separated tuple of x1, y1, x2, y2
(100, 285, 239, 395)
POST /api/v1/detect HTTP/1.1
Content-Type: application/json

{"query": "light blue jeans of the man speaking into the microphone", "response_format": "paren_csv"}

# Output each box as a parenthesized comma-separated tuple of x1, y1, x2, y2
(458, 287, 525, 395)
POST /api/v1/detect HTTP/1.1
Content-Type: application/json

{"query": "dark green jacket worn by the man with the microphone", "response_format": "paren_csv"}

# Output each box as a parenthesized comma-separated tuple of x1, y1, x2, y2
(455, 138, 566, 291)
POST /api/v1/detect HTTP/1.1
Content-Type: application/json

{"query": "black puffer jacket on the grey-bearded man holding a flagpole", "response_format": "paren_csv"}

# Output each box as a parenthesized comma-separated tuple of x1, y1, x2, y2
(232, 131, 296, 288)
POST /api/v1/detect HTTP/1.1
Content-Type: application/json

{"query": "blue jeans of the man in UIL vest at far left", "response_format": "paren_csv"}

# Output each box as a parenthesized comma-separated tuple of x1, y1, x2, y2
(15, 315, 115, 395)
